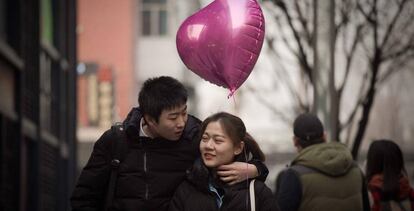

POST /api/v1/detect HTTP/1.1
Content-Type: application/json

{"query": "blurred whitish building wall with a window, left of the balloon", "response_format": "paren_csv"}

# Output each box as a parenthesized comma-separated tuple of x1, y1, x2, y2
(135, 0, 201, 115)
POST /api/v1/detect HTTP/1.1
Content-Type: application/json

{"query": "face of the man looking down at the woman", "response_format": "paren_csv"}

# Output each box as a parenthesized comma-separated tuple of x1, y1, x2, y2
(148, 104, 188, 141)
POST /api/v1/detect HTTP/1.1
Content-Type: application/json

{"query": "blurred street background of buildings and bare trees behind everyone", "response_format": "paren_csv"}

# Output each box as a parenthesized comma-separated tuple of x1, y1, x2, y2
(0, 0, 414, 211)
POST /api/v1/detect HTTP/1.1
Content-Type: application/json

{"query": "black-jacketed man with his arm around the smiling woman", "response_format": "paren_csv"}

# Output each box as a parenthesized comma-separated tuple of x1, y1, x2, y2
(71, 76, 267, 211)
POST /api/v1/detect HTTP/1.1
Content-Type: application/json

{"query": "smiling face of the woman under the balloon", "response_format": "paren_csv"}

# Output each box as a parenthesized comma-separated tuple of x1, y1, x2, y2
(200, 121, 242, 168)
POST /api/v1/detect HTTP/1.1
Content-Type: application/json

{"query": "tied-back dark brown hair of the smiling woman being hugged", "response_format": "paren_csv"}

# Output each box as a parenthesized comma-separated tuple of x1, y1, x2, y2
(200, 112, 265, 162)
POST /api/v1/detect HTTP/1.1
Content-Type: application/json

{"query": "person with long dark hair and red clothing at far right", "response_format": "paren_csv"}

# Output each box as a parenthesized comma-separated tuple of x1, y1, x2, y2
(366, 140, 414, 211)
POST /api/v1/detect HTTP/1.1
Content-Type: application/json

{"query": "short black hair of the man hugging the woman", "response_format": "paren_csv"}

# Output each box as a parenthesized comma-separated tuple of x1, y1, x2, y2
(138, 76, 188, 122)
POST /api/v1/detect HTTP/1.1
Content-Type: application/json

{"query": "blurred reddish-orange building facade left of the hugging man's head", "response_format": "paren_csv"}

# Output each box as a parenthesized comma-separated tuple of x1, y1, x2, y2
(77, 0, 138, 170)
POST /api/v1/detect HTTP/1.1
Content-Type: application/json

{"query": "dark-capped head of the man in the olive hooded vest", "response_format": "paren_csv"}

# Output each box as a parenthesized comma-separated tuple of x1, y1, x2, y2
(293, 113, 324, 148)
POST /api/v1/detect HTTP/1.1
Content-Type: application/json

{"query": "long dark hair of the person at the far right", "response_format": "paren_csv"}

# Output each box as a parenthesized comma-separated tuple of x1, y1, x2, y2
(366, 140, 407, 199)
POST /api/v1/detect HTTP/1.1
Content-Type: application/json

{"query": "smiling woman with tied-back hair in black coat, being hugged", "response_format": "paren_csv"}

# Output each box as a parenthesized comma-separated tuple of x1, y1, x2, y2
(169, 112, 277, 211)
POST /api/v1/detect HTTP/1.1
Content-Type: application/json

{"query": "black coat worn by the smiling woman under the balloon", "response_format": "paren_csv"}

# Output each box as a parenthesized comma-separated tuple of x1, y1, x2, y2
(169, 160, 278, 211)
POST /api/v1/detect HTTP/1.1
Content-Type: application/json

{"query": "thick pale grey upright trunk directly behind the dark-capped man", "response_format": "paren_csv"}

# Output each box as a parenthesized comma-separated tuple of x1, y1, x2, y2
(312, 0, 337, 141)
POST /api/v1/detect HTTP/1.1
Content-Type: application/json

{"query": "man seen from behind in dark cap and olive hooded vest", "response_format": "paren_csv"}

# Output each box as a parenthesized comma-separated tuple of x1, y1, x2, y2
(276, 114, 369, 211)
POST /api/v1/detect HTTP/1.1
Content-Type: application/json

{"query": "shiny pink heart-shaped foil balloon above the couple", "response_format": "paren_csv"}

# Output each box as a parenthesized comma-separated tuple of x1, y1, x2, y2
(176, 0, 265, 95)
